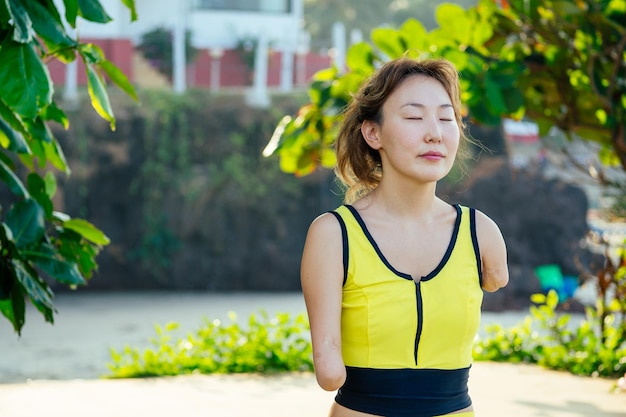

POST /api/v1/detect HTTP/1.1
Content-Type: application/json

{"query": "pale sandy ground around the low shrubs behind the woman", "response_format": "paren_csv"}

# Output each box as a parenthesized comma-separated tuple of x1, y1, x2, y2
(0, 293, 626, 417)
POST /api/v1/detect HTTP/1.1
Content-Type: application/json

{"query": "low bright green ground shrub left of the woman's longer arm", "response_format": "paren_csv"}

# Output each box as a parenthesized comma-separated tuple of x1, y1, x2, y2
(108, 311, 313, 378)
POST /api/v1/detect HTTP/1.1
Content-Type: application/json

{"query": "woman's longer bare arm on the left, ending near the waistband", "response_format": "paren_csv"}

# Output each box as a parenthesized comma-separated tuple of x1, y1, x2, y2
(301, 214, 346, 391)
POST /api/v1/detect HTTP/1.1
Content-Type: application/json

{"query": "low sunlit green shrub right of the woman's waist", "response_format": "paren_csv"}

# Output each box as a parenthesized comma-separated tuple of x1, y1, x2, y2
(474, 237, 626, 377)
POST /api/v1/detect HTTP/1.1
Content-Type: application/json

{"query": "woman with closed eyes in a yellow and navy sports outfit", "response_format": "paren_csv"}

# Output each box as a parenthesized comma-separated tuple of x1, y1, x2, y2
(301, 58, 508, 417)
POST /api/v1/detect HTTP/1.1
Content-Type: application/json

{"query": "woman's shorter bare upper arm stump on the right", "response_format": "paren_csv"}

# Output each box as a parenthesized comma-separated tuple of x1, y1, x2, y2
(476, 210, 509, 292)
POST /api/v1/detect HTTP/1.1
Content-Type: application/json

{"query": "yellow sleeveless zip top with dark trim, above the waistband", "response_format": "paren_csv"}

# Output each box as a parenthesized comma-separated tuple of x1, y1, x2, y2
(333, 205, 483, 370)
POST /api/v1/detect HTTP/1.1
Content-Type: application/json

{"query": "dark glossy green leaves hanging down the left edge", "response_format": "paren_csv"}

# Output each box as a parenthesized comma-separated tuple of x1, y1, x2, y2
(0, 0, 136, 334)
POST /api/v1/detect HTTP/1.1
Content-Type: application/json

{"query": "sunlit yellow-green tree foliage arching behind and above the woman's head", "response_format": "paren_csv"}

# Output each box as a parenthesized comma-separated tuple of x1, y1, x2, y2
(267, 0, 626, 180)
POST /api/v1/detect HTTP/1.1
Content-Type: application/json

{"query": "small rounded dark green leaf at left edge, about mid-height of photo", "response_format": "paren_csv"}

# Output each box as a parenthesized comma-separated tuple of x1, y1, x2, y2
(6, 198, 45, 248)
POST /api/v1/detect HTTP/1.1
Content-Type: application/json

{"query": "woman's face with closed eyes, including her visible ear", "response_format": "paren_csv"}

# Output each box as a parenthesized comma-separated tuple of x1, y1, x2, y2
(361, 75, 460, 182)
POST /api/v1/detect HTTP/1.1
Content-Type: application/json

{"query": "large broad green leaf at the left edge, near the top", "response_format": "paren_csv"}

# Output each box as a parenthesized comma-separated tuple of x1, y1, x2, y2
(0, 42, 53, 119)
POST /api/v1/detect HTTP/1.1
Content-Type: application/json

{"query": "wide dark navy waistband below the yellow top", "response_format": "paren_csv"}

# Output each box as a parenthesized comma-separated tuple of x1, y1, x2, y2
(335, 366, 472, 417)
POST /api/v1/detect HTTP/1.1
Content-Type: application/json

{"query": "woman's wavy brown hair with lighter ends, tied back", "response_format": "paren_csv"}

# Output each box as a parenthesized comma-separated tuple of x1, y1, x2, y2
(335, 57, 468, 203)
